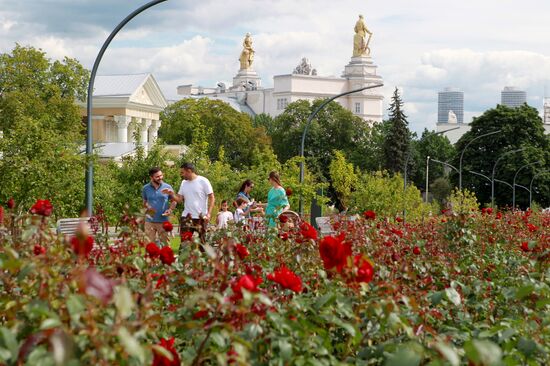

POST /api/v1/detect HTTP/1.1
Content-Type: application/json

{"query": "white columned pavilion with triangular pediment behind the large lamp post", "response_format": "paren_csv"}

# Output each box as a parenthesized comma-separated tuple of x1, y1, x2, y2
(80, 73, 168, 160)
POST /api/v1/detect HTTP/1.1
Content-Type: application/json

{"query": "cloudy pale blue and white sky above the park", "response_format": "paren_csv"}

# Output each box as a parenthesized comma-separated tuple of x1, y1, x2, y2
(0, 0, 550, 132)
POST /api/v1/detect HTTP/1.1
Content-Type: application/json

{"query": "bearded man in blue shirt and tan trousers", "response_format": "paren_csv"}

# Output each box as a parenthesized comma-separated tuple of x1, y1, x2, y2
(141, 167, 177, 245)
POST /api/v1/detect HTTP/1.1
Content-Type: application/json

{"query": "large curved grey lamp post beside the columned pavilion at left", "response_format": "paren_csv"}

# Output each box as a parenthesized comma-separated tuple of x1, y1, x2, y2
(86, 0, 167, 216)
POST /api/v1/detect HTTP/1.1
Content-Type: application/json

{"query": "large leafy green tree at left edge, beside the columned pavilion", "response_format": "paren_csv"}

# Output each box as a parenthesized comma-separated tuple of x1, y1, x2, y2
(0, 45, 88, 216)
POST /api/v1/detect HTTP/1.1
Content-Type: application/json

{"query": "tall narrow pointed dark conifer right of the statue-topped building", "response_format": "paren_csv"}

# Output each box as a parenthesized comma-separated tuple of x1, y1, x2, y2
(383, 88, 411, 173)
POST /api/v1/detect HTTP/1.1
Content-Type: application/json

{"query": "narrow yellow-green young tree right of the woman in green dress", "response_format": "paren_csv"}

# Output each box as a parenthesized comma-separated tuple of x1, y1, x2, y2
(329, 150, 358, 211)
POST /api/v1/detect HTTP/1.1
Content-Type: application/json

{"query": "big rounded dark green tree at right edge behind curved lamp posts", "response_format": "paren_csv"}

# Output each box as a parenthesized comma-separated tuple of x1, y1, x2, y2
(452, 105, 550, 208)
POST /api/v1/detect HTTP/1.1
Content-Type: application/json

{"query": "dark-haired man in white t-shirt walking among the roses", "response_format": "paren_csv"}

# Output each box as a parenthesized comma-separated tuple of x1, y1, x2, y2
(166, 163, 216, 243)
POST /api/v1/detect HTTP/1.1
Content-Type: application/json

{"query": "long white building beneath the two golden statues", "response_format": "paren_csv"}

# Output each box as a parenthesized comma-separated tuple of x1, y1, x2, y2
(177, 46, 384, 122)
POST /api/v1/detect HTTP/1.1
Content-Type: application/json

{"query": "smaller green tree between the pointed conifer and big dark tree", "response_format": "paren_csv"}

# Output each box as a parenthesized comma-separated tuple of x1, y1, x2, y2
(411, 129, 456, 190)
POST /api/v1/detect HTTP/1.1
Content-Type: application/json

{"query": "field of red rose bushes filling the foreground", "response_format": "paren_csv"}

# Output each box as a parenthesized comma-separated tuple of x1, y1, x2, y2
(0, 200, 550, 365)
